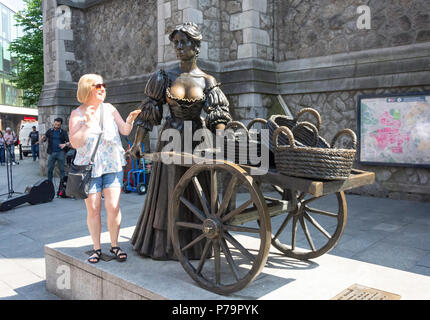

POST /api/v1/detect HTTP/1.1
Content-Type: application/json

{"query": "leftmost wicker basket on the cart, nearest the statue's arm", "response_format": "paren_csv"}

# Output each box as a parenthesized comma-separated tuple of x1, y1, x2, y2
(224, 119, 267, 165)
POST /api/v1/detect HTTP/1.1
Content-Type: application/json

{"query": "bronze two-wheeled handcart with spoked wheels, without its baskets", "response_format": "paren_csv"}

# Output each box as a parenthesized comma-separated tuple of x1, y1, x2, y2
(144, 153, 375, 295)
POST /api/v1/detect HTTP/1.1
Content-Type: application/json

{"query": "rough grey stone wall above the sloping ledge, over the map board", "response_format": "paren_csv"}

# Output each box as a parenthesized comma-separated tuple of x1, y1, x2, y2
(275, 0, 430, 61)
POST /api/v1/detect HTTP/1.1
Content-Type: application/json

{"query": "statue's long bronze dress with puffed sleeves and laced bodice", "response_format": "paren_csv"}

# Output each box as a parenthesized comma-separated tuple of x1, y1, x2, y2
(130, 69, 231, 260)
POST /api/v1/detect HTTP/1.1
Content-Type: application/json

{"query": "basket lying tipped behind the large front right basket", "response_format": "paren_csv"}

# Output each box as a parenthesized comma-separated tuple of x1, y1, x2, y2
(263, 107, 330, 152)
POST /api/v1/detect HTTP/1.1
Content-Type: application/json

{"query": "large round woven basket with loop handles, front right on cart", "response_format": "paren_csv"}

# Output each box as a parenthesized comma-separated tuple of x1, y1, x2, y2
(273, 122, 357, 180)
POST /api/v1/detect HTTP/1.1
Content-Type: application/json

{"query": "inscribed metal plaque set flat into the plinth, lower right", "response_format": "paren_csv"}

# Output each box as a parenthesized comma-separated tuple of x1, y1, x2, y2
(331, 284, 400, 300)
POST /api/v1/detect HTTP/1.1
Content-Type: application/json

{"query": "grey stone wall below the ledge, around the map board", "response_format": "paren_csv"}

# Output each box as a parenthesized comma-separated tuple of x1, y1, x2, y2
(283, 86, 430, 201)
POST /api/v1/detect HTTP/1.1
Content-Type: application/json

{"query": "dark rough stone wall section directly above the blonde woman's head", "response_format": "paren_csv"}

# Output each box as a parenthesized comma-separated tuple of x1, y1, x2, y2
(78, 0, 157, 81)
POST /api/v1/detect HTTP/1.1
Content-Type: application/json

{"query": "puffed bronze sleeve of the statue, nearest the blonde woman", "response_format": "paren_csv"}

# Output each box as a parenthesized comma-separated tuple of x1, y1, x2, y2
(134, 70, 169, 131)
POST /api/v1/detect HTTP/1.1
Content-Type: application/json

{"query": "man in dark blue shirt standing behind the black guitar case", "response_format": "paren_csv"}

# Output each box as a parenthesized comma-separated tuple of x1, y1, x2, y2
(41, 118, 70, 181)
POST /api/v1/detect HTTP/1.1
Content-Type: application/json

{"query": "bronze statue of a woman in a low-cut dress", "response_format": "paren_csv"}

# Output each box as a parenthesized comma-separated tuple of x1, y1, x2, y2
(130, 22, 232, 260)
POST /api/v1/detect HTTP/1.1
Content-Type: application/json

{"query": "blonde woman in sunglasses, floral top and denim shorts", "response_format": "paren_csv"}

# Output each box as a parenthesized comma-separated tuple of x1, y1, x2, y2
(69, 74, 140, 263)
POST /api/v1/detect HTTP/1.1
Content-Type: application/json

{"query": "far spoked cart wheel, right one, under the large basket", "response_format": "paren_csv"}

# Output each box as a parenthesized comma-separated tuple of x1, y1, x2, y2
(272, 187, 347, 260)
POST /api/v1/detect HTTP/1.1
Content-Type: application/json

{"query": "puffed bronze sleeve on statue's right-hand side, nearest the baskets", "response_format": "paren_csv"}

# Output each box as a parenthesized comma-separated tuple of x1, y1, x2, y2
(205, 83, 232, 132)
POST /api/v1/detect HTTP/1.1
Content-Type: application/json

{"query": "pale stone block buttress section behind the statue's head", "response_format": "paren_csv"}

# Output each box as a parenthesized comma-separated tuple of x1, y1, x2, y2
(159, 0, 273, 62)
